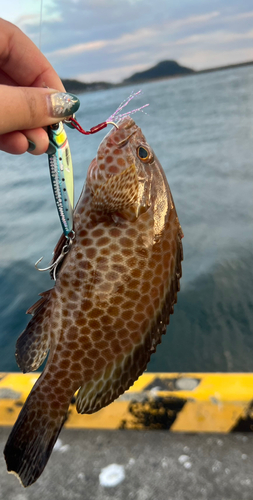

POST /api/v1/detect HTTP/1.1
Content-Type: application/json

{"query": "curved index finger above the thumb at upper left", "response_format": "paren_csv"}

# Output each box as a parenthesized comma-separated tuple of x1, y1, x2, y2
(0, 19, 65, 92)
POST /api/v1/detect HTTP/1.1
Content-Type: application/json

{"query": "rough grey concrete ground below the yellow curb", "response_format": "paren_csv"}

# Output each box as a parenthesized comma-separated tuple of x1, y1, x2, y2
(0, 427, 253, 500)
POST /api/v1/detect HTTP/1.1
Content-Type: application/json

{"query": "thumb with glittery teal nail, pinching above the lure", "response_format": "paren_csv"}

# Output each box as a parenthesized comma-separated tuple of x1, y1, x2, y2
(0, 85, 80, 134)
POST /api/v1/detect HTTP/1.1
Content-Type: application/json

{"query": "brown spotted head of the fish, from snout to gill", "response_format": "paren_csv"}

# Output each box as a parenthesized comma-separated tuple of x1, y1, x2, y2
(87, 116, 155, 220)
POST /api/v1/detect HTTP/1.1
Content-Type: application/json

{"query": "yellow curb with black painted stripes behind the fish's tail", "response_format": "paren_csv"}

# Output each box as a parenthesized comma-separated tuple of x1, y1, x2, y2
(0, 373, 253, 432)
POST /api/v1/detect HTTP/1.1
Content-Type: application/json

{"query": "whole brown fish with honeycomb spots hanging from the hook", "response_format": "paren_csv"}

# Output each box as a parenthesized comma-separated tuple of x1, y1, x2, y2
(4, 116, 183, 487)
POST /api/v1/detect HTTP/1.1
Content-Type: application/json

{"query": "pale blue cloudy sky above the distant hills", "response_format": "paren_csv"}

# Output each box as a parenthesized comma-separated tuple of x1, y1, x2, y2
(0, 0, 253, 82)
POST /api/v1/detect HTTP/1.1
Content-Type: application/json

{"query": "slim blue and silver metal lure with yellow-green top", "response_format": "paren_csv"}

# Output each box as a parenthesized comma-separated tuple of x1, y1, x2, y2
(48, 122, 74, 237)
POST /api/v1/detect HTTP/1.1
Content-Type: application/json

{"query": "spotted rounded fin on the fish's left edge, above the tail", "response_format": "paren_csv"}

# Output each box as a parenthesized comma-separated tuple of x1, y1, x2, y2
(15, 290, 51, 373)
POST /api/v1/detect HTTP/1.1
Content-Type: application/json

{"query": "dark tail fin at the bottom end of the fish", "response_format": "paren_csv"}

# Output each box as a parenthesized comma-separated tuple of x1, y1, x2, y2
(4, 377, 68, 487)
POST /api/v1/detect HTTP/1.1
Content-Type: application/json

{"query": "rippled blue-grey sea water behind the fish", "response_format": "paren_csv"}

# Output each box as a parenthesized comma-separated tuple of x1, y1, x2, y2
(0, 66, 253, 372)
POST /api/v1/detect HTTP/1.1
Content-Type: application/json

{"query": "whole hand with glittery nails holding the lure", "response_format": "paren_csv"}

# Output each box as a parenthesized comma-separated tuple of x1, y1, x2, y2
(0, 19, 79, 155)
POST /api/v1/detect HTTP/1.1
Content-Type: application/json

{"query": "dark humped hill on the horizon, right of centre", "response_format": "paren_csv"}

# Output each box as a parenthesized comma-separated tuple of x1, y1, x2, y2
(123, 61, 195, 84)
